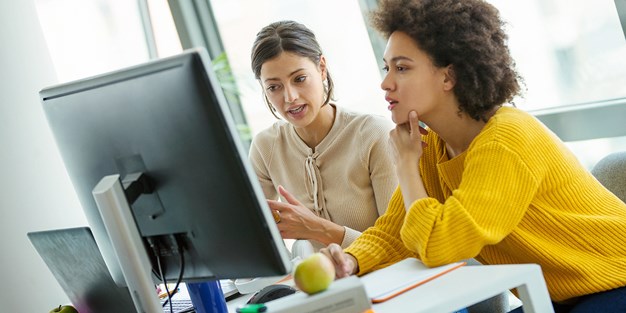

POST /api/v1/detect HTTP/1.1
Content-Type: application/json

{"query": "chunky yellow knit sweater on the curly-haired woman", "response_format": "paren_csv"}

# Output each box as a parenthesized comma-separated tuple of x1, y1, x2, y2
(346, 107, 626, 301)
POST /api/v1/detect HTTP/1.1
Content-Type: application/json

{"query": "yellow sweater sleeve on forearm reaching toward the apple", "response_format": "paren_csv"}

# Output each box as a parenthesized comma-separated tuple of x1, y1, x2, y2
(345, 188, 416, 275)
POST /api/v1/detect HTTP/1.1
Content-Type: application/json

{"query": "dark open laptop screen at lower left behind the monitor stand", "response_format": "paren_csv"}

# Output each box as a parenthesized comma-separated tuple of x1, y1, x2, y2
(27, 227, 200, 313)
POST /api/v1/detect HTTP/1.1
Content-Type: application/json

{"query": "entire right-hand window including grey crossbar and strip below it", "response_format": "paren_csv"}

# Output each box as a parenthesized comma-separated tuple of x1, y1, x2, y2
(489, 0, 626, 168)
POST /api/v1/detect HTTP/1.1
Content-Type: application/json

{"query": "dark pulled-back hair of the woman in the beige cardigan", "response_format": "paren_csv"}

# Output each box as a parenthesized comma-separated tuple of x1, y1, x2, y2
(250, 21, 335, 119)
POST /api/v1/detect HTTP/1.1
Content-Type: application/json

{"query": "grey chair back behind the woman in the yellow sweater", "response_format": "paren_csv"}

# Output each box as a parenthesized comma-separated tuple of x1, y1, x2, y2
(591, 151, 626, 202)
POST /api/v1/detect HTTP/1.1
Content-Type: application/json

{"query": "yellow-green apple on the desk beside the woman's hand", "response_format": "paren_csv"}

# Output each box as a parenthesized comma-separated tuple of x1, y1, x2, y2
(293, 252, 335, 295)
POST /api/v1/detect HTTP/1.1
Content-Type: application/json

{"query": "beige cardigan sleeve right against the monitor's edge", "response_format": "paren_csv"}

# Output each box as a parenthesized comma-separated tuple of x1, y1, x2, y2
(249, 133, 278, 200)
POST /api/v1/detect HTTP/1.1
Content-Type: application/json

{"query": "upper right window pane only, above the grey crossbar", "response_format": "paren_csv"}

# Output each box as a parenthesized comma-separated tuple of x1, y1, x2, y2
(489, 0, 626, 111)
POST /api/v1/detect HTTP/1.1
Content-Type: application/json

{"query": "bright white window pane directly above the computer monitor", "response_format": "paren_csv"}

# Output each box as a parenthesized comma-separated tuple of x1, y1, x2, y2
(35, 0, 149, 82)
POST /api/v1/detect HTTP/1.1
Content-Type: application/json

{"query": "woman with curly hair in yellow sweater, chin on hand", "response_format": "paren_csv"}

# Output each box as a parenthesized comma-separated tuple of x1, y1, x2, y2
(322, 0, 626, 312)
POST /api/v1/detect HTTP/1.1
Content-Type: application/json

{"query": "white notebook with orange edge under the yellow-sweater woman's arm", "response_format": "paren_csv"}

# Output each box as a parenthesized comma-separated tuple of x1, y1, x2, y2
(361, 258, 466, 303)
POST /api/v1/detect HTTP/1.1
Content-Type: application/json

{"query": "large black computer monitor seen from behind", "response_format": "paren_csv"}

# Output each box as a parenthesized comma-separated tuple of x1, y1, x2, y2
(40, 49, 291, 286)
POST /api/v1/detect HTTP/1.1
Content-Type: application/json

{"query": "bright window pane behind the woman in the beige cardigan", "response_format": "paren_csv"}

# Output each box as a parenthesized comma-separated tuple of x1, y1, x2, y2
(211, 0, 389, 134)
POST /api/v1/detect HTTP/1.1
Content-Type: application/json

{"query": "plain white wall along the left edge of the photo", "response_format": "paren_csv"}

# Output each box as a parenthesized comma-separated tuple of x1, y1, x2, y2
(0, 0, 87, 312)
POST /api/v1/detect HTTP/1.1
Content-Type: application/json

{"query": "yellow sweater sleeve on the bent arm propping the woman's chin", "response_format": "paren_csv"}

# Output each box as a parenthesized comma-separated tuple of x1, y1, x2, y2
(400, 142, 539, 266)
